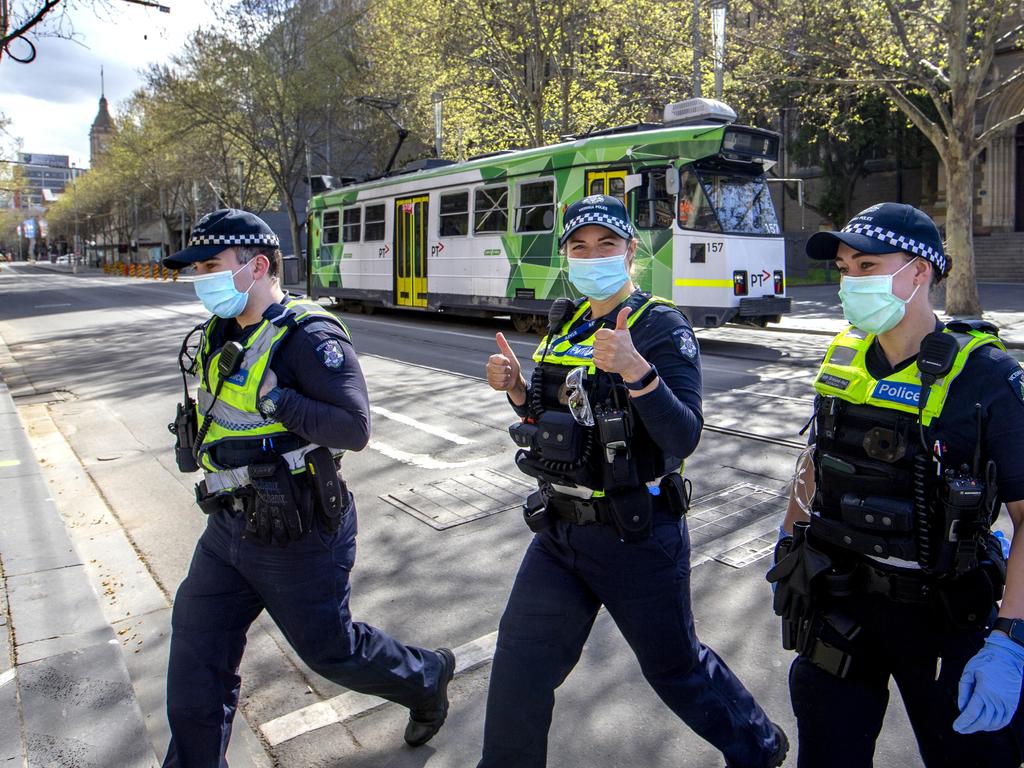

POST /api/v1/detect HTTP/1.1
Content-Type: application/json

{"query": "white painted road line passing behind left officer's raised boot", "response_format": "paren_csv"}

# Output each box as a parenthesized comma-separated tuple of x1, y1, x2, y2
(259, 632, 498, 746)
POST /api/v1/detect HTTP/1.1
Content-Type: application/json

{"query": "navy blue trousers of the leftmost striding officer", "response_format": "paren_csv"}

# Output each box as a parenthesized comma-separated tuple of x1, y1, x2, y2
(164, 502, 440, 768)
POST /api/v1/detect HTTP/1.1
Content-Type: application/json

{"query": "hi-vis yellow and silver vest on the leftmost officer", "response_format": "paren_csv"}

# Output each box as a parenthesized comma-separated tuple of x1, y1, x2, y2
(196, 299, 348, 470)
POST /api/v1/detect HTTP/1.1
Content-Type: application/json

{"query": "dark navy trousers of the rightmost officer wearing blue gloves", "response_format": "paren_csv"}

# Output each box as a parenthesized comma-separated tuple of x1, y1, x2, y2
(790, 595, 1022, 768)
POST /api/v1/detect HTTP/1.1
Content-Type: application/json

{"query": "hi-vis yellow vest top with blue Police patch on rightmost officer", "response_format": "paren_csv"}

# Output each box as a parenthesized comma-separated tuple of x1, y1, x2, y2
(814, 326, 1006, 427)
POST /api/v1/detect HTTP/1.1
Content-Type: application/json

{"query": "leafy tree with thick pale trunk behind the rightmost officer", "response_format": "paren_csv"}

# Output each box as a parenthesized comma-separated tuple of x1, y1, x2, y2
(741, 0, 1024, 315)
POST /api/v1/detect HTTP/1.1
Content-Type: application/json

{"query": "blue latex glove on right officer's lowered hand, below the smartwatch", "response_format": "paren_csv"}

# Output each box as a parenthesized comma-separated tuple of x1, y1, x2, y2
(953, 632, 1024, 733)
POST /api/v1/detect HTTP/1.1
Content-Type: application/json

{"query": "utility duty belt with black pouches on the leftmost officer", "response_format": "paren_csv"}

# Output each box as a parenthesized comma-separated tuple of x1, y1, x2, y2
(196, 446, 349, 546)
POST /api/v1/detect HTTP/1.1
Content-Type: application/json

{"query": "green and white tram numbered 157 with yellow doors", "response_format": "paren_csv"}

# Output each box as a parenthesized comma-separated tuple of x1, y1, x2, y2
(306, 99, 790, 330)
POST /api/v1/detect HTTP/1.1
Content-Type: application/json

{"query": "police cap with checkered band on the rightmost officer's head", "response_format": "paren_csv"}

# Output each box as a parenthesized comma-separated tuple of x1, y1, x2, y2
(807, 203, 949, 275)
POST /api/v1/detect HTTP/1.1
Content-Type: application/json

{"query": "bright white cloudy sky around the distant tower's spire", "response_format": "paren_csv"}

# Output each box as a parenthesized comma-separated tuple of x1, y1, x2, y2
(0, 0, 213, 165)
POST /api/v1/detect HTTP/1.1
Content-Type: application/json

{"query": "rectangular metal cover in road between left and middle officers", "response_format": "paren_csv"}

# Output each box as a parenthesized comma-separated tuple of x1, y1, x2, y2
(379, 469, 535, 530)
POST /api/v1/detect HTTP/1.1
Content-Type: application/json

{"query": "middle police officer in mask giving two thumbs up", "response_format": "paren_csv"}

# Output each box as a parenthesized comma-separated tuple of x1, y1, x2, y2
(479, 196, 787, 768)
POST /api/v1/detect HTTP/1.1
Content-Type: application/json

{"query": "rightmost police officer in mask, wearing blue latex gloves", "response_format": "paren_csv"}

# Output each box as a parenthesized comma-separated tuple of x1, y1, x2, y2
(769, 203, 1024, 768)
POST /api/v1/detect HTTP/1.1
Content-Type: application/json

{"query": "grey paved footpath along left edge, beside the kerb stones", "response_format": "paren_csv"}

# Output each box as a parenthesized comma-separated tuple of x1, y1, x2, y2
(0, 381, 158, 768)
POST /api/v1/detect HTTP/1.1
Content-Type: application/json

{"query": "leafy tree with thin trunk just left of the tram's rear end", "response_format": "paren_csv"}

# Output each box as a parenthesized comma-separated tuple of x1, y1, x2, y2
(147, 0, 362, 260)
